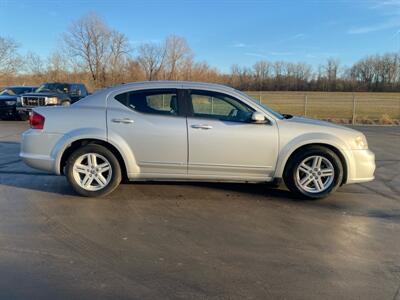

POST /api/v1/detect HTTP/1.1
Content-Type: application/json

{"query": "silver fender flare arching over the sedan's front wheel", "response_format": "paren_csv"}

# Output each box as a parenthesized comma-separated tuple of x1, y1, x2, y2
(274, 133, 350, 178)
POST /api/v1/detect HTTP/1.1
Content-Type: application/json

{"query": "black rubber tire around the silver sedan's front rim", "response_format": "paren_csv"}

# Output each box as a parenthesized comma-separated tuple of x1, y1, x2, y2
(283, 145, 343, 199)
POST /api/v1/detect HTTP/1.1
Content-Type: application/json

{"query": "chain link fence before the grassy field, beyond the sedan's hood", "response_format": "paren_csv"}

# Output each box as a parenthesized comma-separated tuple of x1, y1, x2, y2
(246, 91, 400, 125)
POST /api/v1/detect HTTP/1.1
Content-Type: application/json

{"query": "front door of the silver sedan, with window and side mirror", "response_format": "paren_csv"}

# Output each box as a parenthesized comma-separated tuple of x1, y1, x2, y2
(187, 90, 278, 181)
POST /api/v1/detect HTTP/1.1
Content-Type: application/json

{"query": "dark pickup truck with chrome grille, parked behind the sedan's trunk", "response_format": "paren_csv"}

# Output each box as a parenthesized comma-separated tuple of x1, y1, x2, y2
(17, 82, 88, 119)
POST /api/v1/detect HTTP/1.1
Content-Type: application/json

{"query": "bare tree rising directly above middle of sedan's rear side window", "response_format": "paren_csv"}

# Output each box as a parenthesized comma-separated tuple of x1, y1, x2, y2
(137, 43, 166, 80)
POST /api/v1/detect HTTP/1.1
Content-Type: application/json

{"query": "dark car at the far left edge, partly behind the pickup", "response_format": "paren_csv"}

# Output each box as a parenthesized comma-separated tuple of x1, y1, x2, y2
(0, 86, 37, 119)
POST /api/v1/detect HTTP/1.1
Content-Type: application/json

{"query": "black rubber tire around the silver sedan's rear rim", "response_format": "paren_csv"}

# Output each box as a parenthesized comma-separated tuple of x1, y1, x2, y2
(65, 144, 122, 197)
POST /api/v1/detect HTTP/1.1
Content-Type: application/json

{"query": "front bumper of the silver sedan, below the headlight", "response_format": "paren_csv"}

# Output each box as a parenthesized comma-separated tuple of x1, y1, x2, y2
(346, 149, 376, 183)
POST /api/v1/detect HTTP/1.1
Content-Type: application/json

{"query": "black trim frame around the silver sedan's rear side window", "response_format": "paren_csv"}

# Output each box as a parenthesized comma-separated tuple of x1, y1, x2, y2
(113, 88, 187, 117)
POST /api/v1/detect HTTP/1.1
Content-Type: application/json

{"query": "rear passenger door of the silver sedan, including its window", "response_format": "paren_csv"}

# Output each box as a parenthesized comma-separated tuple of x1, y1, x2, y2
(107, 89, 187, 178)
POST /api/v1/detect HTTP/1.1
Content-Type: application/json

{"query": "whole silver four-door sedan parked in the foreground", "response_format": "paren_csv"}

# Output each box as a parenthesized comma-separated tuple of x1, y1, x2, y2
(20, 81, 375, 199)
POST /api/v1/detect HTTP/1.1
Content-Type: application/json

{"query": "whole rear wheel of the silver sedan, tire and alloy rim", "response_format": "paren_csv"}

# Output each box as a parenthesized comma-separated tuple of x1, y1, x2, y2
(66, 144, 121, 197)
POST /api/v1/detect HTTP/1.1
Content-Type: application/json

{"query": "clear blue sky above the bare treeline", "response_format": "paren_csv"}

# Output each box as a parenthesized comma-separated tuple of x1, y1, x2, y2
(0, 0, 400, 72)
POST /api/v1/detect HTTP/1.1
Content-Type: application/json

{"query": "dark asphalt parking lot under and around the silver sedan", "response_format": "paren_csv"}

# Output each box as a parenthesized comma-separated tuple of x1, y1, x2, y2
(0, 121, 400, 299)
